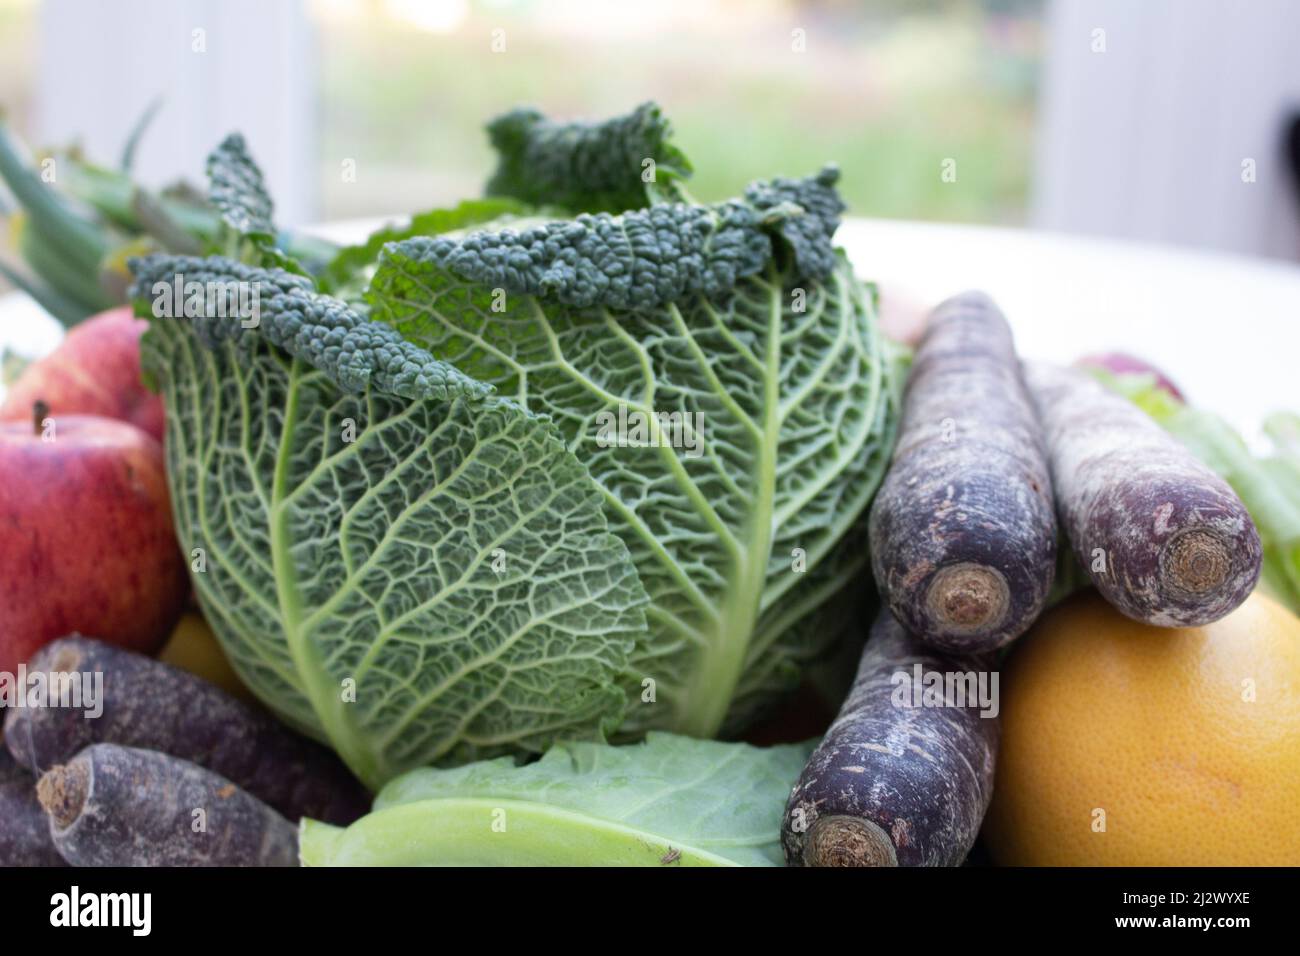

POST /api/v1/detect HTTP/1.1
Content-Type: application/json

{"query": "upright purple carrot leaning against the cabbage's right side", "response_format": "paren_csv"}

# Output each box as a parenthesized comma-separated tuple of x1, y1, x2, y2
(870, 293, 1057, 653)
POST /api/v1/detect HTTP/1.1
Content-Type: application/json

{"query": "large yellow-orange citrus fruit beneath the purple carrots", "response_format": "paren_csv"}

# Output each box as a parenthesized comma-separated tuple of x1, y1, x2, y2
(984, 593, 1300, 866)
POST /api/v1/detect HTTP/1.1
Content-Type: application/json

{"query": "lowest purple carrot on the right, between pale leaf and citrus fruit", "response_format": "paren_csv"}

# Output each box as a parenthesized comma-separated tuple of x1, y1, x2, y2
(781, 610, 998, 866)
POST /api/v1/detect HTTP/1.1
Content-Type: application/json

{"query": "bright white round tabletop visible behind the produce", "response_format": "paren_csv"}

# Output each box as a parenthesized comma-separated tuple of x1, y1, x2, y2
(0, 219, 1300, 438)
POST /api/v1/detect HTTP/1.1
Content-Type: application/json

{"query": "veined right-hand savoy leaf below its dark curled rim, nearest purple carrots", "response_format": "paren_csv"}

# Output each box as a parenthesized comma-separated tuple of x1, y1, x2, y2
(372, 243, 896, 736)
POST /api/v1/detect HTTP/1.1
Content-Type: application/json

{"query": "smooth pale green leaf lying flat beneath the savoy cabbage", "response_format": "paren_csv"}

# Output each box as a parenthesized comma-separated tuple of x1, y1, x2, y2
(300, 734, 811, 866)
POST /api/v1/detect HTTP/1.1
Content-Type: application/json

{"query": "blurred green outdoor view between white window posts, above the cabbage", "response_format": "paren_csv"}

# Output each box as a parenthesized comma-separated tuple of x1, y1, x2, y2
(312, 0, 1043, 224)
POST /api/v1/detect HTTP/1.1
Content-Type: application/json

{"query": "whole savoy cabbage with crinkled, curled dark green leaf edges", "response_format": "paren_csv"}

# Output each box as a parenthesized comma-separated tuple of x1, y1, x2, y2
(133, 105, 898, 786)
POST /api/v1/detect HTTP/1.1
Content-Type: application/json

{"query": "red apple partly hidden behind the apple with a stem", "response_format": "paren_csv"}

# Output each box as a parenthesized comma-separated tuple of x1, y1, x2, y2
(0, 306, 163, 441)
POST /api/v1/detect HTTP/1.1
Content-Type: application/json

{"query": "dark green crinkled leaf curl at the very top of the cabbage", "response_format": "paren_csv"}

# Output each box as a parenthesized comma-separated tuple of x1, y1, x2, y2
(488, 103, 690, 212)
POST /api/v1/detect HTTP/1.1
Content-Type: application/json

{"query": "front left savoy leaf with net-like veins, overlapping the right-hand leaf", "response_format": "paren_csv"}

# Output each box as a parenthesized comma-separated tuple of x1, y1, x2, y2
(135, 258, 646, 786)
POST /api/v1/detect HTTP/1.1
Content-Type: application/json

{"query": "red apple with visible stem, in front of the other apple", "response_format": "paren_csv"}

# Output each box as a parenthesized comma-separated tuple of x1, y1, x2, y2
(0, 408, 189, 674)
